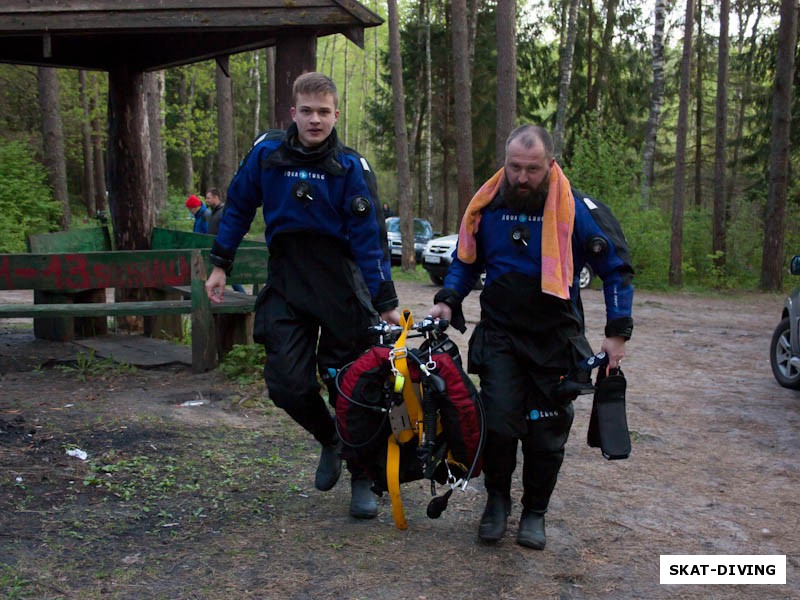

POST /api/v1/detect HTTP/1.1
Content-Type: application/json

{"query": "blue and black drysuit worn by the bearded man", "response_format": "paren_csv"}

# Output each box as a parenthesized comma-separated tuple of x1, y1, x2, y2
(434, 189, 633, 512)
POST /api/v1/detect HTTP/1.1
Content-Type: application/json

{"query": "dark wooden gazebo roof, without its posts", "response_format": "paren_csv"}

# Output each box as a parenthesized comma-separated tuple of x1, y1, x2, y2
(0, 0, 383, 71)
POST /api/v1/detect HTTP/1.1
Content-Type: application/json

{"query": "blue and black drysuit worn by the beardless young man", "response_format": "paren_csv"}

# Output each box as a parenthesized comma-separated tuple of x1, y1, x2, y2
(212, 124, 397, 468)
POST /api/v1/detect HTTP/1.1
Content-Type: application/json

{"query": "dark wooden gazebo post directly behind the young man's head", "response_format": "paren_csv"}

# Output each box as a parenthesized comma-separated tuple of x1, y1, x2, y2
(273, 33, 317, 129)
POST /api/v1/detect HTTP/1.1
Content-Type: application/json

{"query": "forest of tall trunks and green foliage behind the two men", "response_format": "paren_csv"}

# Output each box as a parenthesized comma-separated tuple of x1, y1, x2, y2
(0, 0, 800, 289)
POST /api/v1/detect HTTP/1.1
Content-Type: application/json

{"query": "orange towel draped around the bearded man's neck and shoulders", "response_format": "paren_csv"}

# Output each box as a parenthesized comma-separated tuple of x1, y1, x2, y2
(458, 162, 575, 300)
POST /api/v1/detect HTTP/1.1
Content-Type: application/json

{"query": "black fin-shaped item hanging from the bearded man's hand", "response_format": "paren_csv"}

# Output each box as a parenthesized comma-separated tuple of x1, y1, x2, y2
(586, 368, 631, 460)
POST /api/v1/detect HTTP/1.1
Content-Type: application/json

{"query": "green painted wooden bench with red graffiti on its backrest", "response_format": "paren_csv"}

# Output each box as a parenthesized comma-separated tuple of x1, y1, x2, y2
(0, 228, 269, 372)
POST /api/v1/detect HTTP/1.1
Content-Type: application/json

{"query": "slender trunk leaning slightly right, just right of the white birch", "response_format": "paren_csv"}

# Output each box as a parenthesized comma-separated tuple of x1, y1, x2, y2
(669, 0, 694, 286)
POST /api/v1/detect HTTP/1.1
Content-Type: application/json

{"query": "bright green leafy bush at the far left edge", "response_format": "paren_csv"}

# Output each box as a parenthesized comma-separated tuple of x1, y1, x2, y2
(0, 140, 59, 252)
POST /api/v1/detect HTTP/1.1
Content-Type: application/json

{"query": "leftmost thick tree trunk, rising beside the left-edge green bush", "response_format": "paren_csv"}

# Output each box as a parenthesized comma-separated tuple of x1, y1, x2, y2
(37, 67, 70, 231)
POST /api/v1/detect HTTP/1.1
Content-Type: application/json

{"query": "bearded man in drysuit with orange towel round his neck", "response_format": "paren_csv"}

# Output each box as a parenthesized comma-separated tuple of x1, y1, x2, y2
(430, 125, 633, 550)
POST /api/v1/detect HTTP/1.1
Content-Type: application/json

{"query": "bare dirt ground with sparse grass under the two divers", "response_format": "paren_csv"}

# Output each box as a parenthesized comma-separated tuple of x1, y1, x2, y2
(0, 283, 800, 600)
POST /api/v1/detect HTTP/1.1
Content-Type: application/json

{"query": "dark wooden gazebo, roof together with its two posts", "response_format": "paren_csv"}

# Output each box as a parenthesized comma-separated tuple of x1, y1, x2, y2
(0, 0, 383, 249)
